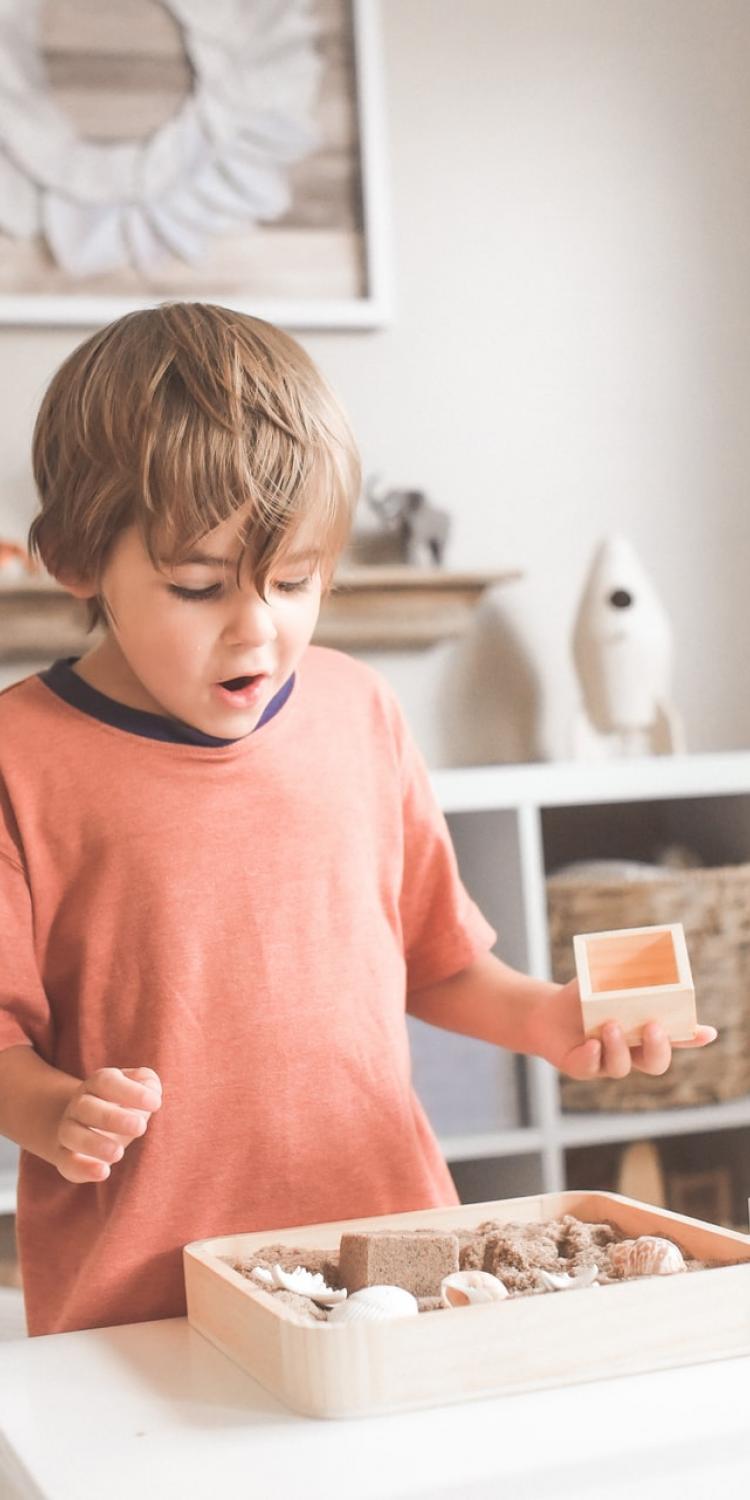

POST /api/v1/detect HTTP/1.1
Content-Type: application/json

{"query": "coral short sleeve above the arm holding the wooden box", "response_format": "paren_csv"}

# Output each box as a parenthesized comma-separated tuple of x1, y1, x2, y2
(401, 725, 497, 992)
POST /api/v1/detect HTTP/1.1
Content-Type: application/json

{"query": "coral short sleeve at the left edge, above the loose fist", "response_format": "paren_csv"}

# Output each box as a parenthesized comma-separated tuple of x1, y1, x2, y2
(0, 848, 51, 1052)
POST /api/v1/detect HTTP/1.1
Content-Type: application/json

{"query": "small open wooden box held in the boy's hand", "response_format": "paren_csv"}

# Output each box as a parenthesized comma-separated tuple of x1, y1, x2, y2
(573, 923, 698, 1047)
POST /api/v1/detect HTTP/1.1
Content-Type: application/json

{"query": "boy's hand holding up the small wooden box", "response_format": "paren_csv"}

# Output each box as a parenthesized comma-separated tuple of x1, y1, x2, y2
(539, 980, 717, 1080)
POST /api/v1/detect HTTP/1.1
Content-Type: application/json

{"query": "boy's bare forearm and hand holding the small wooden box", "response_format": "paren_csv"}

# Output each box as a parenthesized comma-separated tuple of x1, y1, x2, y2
(407, 953, 716, 1079)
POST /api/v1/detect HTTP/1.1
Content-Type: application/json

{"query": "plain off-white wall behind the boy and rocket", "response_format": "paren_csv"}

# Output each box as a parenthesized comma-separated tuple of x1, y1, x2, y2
(0, 0, 750, 764)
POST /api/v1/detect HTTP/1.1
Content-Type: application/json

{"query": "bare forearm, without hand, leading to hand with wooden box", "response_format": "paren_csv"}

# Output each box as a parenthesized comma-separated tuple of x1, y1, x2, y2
(407, 953, 560, 1053)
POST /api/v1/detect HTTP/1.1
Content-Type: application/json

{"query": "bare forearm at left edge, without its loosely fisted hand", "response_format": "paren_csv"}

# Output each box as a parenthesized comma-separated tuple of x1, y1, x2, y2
(0, 1044, 81, 1166)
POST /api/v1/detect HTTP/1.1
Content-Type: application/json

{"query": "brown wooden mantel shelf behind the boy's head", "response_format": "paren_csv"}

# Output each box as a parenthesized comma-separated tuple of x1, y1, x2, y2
(0, 566, 521, 662)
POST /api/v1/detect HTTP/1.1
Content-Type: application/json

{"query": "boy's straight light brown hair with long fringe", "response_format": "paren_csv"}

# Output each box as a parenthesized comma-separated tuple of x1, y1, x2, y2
(29, 302, 360, 626)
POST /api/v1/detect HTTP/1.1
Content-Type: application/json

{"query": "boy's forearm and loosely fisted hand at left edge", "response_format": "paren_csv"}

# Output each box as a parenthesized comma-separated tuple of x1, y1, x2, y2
(0, 1044, 161, 1182)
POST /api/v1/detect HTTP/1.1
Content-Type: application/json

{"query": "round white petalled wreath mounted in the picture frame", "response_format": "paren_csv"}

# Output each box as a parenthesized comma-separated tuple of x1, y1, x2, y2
(0, 0, 320, 279)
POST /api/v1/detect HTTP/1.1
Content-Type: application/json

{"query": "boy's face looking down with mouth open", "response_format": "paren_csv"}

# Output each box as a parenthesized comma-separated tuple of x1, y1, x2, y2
(75, 518, 321, 740)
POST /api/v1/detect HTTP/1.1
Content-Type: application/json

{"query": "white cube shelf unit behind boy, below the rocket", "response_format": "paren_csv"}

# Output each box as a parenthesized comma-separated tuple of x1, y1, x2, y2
(429, 752, 750, 1196)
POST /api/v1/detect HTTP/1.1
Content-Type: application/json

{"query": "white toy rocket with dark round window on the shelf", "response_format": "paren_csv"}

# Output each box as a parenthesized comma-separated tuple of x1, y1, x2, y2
(573, 536, 686, 759)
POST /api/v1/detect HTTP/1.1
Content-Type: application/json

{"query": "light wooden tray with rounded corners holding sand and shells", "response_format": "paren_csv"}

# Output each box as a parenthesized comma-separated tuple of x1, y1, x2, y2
(185, 1193, 750, 1418)
